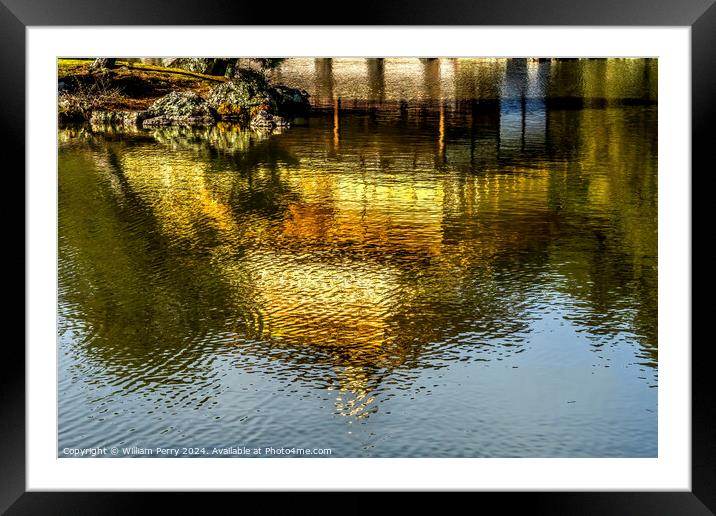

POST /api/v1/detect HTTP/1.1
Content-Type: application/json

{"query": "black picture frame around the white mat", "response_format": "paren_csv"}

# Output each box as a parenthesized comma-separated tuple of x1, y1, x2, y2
(0, 0, 716, 515)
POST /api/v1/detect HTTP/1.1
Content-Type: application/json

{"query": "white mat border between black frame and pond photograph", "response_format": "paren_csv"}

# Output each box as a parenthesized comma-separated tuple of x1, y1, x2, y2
(26, 27, 691, 491)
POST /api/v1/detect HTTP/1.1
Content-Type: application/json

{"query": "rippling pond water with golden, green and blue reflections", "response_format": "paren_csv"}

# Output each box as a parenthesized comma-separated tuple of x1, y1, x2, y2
(58, 59, 657, 457)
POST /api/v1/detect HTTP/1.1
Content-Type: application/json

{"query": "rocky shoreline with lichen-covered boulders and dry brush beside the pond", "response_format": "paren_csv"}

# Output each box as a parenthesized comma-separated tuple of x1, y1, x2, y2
(58, 59, 310, 130)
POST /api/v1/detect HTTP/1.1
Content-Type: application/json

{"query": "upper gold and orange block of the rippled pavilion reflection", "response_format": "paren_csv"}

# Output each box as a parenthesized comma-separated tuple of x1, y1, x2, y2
(282, 170, 444, 255)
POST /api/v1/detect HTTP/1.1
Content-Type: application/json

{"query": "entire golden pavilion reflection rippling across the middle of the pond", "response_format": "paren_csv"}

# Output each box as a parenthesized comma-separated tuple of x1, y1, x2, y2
(116, 137, 547, 361)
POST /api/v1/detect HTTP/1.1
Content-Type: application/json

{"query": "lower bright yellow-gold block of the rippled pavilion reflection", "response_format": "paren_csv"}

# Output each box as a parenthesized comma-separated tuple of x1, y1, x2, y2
(249, 253, 398, 351)
